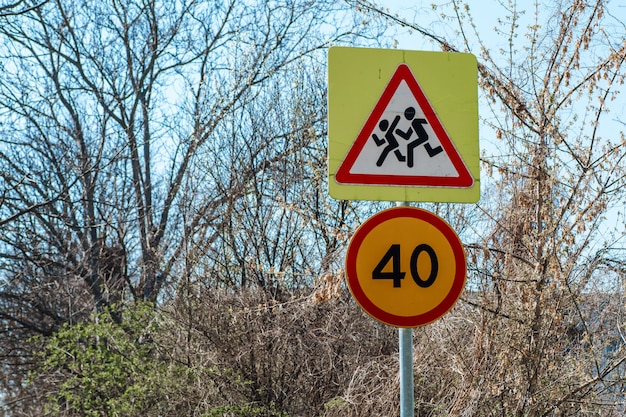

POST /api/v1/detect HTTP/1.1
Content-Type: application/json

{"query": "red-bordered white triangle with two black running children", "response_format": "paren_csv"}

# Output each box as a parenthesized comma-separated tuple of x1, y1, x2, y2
(335, 64, 474, 188)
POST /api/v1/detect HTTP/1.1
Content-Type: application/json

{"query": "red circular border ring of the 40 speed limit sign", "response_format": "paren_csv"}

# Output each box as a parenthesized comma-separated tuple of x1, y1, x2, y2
(346, 207, 467, 327)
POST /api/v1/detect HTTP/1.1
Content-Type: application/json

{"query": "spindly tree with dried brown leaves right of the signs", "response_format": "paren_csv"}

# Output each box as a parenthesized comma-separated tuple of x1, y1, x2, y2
(358, 1, 626, 416)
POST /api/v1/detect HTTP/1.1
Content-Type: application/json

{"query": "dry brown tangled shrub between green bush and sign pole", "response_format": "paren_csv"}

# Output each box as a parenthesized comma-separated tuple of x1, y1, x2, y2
(166, 289, 398, 417)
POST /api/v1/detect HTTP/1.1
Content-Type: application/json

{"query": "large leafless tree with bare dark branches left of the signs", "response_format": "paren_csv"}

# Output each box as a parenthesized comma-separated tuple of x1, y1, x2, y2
(0, 0, 370, 410)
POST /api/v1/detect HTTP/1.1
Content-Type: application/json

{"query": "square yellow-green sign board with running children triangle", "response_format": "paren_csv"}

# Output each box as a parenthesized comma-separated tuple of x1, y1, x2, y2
(328, 47, 480, 202)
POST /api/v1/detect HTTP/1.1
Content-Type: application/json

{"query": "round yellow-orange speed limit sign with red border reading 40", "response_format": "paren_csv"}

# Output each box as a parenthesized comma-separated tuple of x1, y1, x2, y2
(346, 207, 467, 327)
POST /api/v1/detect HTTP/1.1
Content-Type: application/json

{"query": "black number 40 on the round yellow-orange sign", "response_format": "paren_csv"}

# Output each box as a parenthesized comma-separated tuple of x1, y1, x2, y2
(372, 243, 439, 288)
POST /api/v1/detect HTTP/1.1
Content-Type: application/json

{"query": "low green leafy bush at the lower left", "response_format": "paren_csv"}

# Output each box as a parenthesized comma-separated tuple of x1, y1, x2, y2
(38, 304, 162, 417)
